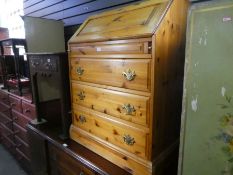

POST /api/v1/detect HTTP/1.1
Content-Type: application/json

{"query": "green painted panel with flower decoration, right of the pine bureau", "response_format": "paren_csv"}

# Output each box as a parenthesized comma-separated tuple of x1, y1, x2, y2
(178, 0, 233, 175)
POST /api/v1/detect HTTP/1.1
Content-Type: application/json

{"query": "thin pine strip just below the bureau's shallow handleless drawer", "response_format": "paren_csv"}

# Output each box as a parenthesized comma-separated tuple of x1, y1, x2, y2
(70, 53, 151, 59)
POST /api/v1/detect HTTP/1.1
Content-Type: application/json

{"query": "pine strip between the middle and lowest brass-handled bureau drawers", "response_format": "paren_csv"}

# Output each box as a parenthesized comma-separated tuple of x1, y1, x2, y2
(73, 103, 149, 134)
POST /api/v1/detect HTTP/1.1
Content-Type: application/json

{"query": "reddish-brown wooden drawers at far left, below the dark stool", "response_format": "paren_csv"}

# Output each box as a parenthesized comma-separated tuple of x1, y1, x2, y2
(0, 91, 35, 172)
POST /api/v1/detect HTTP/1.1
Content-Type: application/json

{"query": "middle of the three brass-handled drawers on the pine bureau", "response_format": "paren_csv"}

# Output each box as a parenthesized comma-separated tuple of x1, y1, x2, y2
(72, 83, 150, 125)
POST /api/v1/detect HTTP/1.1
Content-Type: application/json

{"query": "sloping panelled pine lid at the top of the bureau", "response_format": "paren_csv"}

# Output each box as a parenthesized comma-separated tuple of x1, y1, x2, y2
(69, 0, 172, 43)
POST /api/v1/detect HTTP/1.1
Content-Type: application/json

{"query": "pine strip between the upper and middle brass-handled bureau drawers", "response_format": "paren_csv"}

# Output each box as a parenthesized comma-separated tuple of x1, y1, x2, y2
(71, 80, 151, 97)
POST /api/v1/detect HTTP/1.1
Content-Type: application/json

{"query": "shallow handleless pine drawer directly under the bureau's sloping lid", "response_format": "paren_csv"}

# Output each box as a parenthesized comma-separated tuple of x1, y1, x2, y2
(70, 41, 150, 55)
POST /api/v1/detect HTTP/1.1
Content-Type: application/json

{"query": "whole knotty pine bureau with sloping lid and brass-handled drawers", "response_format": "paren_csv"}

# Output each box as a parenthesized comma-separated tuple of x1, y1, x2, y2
(69, 0, 188, 175)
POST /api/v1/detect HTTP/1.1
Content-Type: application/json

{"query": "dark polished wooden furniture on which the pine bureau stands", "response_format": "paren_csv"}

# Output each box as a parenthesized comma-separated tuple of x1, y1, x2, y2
(27, 123, 129, 175)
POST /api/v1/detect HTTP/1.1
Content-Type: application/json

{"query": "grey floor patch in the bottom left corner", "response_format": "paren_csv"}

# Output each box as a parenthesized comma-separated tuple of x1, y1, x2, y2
(0, 144, 27, 175)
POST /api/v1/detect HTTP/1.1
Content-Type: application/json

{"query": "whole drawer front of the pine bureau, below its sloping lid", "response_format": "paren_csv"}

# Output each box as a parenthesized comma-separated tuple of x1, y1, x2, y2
(70, 38, 151, 164)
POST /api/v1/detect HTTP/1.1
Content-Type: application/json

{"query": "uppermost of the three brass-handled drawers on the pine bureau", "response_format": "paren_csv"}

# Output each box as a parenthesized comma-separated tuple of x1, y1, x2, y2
(71, 58, 150, 91)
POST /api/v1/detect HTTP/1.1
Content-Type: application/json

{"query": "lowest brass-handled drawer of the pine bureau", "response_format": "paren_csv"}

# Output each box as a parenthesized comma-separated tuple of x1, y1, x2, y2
(73, 107, 147, 157)
